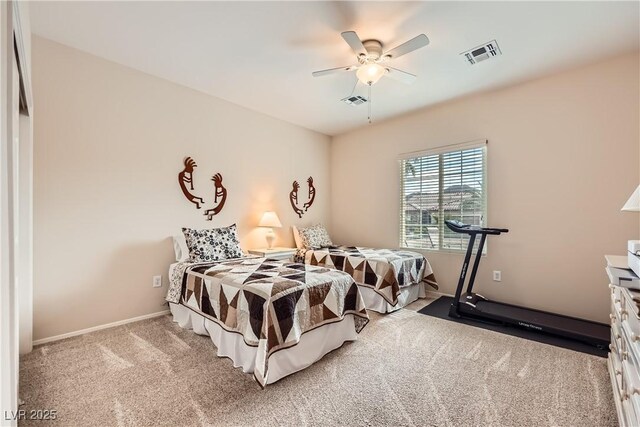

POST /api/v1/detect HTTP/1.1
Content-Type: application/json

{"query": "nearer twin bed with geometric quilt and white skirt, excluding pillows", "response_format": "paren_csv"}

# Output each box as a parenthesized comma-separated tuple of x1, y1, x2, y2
(167, 257, 369, 387)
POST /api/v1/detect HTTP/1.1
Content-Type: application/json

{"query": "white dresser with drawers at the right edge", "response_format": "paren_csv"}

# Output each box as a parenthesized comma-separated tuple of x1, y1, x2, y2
(608, 276, 640, 426)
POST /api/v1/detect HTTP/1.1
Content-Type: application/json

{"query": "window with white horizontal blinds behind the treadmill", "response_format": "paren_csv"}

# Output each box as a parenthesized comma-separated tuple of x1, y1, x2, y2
(400, 141, 487, 251)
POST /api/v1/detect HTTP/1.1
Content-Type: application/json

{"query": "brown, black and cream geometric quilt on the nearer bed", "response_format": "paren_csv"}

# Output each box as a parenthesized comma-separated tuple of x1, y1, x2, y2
(167, 257, 369, 387)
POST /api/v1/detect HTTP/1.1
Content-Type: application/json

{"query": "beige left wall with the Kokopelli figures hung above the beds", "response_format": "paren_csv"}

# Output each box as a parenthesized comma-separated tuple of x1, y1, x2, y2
(33, 37, 330, 340)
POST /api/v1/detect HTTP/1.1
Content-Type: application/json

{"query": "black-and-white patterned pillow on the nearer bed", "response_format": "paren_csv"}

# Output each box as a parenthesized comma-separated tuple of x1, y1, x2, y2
(182, 224, 243, 262)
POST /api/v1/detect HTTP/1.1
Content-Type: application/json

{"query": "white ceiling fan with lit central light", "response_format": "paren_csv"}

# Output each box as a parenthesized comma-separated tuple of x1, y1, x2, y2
(311, 31, 429, 86)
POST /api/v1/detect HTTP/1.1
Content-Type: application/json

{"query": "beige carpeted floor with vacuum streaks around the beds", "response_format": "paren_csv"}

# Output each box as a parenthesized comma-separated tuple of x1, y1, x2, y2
(20, 300, 617, 427)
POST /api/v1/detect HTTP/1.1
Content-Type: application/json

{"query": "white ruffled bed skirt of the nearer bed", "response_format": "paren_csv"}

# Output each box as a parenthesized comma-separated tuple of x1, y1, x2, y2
(169, 303, 358, 384)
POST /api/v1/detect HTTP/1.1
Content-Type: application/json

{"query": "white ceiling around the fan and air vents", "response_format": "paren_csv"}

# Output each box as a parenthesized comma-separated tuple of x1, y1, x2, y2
(30, 1, 640, 135)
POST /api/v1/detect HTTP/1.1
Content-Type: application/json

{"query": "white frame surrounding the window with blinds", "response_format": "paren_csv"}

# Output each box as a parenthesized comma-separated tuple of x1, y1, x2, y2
(398, 139, 489, 255)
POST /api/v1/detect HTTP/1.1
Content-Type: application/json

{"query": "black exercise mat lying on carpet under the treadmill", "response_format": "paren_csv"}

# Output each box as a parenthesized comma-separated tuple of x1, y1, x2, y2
(418, 297, 609, 357)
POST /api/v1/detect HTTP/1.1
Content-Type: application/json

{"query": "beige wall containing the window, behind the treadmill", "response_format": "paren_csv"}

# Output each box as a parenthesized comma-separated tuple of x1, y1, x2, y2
(331, 54, 640, 322)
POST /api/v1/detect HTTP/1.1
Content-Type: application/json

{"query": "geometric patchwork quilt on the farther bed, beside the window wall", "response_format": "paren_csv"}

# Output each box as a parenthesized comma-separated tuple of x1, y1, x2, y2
(297, 246, 438, 306)
